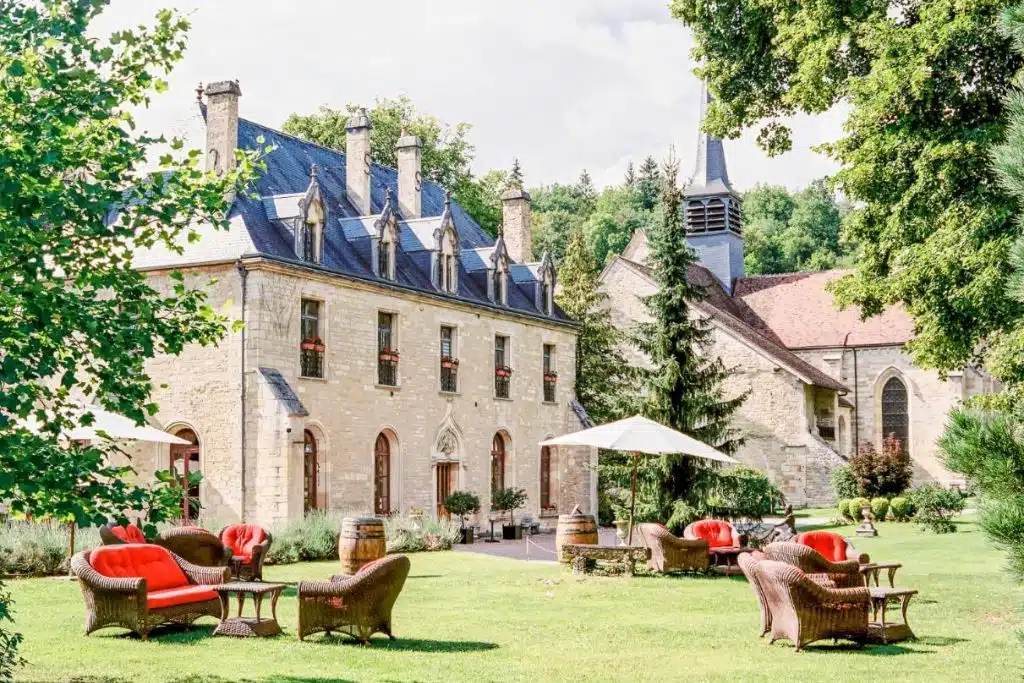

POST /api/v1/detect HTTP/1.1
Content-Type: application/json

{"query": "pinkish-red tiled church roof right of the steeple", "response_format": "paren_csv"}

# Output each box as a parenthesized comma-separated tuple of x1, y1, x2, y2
(732, 270, 913, 348)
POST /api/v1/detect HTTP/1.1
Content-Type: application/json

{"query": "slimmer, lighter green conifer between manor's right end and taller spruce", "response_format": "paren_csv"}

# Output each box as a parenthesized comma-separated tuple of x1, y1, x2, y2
(557, 224, 636, 424)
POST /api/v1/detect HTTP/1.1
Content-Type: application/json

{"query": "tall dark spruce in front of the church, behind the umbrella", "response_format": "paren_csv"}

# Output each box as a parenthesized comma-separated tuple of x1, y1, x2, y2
(636, 154, 746, 523)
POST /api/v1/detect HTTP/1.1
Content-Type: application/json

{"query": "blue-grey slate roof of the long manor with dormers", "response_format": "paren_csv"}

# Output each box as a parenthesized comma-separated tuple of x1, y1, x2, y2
(133, 108, 571, 323)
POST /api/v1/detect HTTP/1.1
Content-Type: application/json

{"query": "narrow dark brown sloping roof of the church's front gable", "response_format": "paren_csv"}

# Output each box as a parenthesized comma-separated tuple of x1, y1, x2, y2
(615, 256, 849, 392)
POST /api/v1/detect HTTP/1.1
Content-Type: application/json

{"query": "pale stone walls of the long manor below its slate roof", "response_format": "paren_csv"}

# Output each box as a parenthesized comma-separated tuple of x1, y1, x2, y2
(123, 259, 596, 525)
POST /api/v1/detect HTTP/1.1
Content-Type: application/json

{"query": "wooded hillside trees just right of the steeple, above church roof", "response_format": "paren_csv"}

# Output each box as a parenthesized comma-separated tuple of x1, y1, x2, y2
(743, 180, 852, 274)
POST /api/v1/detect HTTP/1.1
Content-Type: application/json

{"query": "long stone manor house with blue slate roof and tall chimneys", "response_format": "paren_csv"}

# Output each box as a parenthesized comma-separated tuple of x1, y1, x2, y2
(123, 82, 596, 524)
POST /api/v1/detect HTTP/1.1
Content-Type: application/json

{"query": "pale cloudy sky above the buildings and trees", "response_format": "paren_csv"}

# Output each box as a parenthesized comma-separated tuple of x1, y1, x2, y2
(95, 0, 842, 189)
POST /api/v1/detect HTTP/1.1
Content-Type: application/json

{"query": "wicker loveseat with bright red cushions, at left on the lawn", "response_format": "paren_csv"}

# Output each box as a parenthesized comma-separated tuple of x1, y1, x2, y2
(71, 544, 230, 640)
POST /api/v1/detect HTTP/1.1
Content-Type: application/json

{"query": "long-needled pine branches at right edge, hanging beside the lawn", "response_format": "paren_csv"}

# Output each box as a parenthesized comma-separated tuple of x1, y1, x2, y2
(939, 404, 1024, 577)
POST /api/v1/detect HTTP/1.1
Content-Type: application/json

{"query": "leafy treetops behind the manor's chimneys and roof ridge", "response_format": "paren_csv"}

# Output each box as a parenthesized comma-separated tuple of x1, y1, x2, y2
(282, 95, 495, 234)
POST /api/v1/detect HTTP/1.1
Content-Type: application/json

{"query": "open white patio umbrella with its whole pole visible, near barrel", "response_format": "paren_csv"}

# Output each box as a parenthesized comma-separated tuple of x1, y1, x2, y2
(541, 415, 737, 544)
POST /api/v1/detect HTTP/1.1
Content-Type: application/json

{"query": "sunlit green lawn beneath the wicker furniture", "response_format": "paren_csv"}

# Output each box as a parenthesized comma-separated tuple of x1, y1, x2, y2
(4, 521, 1024, 683)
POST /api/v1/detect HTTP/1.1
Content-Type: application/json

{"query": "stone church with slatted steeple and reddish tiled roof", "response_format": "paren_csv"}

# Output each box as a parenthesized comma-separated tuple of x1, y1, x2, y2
(601, 85, 997, 505)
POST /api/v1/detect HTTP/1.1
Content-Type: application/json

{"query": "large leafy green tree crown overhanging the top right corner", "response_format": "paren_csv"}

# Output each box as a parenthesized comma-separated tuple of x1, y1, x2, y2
(671, 0, 1022, 371)
